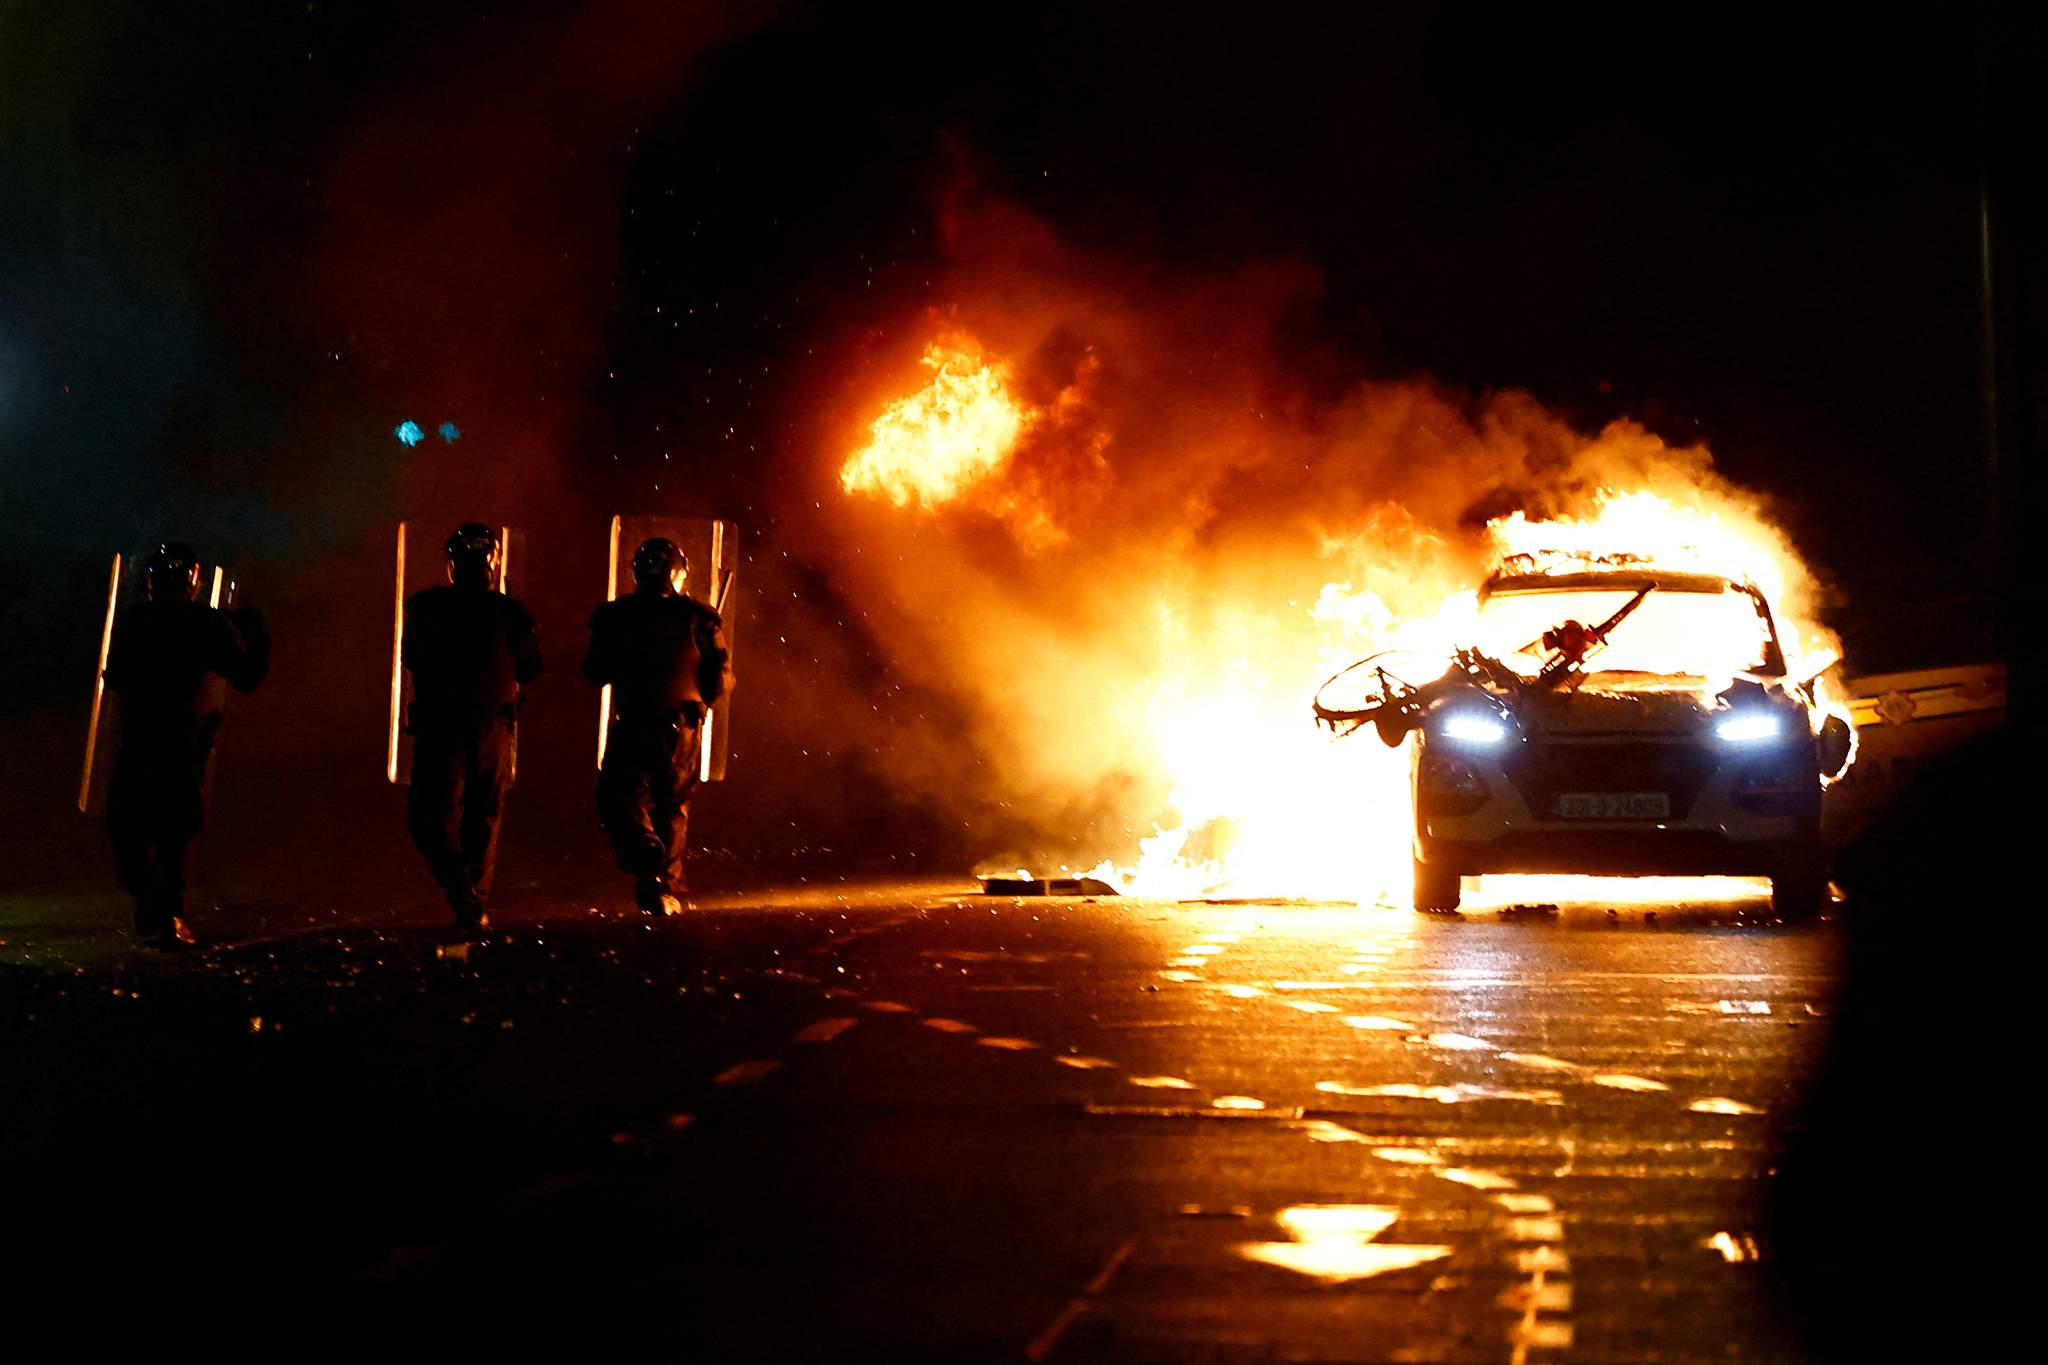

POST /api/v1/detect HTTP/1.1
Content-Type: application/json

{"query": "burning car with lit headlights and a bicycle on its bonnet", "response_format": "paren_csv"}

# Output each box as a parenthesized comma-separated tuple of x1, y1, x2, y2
(1317, 557, 1849, 919)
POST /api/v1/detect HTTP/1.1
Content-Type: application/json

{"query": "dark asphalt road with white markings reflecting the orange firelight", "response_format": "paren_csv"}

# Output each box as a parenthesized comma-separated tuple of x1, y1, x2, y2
(0, 884, 1843, 1363)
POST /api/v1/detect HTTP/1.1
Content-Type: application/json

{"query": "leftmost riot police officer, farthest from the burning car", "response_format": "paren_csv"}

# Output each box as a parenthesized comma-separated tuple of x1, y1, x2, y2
(106, 542, 270, 948)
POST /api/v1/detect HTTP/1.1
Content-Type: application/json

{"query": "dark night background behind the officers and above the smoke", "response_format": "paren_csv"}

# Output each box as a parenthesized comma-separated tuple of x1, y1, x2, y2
(0, 0, 2040, 886)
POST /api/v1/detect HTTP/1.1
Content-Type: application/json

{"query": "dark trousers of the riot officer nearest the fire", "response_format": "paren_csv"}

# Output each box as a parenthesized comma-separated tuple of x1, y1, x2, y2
(598, 716, 702, 894)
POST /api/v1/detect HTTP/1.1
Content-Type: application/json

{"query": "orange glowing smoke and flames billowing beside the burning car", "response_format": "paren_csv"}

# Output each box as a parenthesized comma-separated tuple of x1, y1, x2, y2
(797, 187, 1821, 888)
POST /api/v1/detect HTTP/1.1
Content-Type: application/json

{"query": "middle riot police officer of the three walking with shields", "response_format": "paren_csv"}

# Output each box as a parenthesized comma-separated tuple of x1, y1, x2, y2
(399, 522, 541, 929)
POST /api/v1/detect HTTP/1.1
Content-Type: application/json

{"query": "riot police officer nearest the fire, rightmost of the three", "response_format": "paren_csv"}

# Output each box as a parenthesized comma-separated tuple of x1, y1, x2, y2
(584, 538, 733, 915)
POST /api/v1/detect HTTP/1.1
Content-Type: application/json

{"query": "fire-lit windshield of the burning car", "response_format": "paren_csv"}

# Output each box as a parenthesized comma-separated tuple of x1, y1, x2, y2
(1477, 585, 1772, 677)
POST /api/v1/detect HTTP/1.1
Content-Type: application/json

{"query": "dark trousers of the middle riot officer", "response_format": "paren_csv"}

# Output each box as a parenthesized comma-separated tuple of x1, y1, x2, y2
(406, 720, 514, 900)
